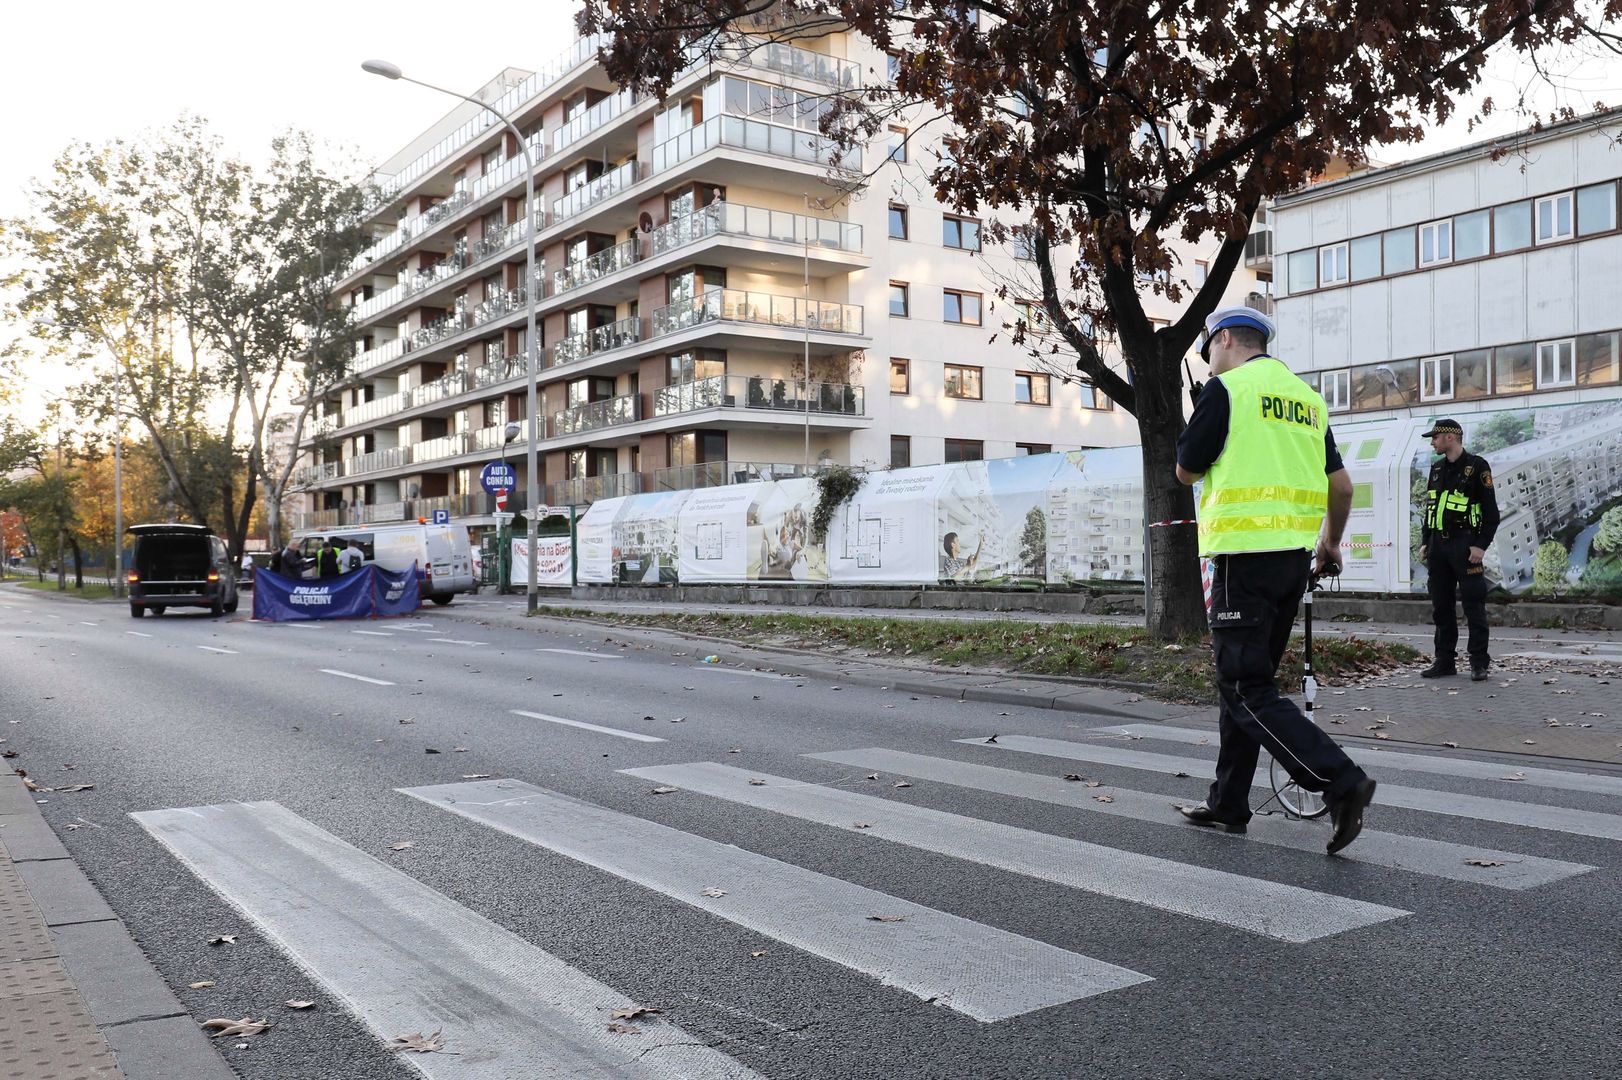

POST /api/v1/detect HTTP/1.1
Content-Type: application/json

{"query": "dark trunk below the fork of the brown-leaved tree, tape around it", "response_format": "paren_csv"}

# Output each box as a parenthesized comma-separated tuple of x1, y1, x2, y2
(1139, 415, 1207, 641)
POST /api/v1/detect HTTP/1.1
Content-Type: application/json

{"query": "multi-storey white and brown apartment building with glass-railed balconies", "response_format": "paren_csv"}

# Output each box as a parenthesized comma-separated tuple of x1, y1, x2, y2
(298, 25, 1270, 527)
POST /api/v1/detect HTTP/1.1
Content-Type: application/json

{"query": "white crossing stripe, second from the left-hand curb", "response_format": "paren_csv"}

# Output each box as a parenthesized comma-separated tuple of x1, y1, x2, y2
(401, 780, 1150, 1022)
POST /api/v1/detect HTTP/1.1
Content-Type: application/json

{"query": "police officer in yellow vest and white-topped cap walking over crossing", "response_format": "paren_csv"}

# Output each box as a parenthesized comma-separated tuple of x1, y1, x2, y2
(1178, 306, 1374, 855)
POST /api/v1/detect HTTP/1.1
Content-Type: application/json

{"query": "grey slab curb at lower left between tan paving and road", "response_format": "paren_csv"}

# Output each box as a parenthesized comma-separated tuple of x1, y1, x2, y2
(0, 770, 237, 1080)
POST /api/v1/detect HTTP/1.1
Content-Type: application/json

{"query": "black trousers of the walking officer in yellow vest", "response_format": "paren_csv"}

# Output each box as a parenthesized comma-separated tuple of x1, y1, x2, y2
(1205, 551, 1364, 822)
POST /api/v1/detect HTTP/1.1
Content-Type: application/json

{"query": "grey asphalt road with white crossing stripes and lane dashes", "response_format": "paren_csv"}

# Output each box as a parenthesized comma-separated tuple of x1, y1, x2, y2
(0, 590, 1622, 1080)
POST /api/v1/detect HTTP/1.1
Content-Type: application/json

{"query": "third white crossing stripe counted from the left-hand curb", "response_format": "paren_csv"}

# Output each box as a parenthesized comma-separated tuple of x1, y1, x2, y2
(621, 762, 1411, 942)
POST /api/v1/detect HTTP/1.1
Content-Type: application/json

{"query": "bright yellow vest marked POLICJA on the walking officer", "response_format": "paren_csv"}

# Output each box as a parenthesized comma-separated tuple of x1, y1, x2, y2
(1199, 357, 1328, 555)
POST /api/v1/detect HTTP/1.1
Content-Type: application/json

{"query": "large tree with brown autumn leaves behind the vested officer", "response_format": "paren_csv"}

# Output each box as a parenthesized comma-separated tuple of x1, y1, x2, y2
(579, 0, 1622, 641)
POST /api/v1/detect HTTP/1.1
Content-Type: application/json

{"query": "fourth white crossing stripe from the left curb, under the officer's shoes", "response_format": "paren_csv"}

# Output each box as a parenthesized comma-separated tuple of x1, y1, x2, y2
(808, 739, 1594, 889)
